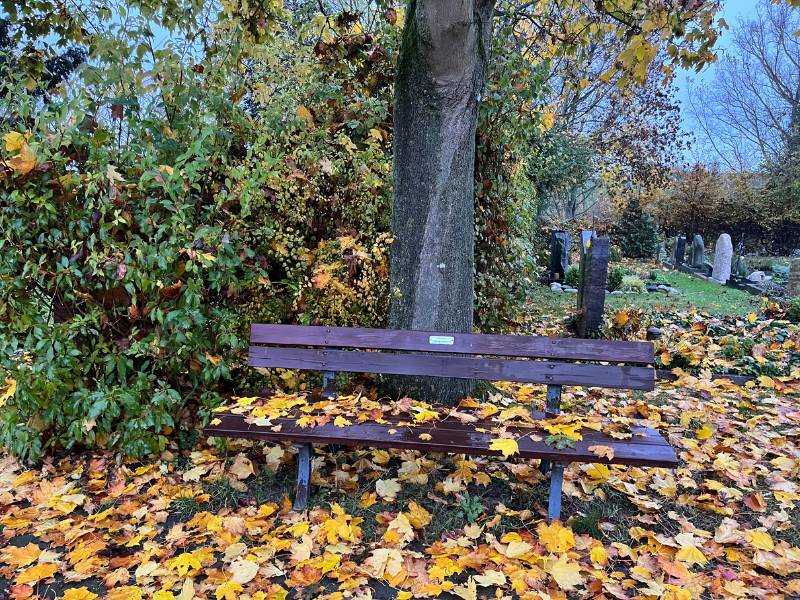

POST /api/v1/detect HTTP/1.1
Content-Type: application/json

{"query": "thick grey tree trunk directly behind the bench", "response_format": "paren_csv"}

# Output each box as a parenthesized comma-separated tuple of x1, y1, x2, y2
(389, 0, 494, 402)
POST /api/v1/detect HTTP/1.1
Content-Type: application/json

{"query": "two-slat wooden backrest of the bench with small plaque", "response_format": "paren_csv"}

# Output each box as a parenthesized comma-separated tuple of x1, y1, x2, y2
(249, 324, 655, 390)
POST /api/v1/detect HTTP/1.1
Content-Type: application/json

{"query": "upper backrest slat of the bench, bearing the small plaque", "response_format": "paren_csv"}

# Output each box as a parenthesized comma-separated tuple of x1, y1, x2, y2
(250, 324, 654, 364)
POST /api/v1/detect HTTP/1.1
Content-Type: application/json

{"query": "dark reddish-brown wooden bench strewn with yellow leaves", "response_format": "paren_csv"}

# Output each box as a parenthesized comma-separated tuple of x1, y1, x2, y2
(204, 324, 678, 518)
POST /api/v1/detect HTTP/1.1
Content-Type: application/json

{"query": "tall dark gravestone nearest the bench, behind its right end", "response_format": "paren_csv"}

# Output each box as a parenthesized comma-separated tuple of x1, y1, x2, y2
(578, 238, 609, 337)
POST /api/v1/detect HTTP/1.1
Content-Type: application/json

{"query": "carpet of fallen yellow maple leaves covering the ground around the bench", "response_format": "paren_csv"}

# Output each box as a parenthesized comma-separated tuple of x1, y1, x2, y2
(0, 314, 800, 600)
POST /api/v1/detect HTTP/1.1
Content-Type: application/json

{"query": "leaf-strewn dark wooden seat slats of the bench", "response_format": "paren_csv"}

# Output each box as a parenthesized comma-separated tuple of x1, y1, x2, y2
(204, 413, 678, 468)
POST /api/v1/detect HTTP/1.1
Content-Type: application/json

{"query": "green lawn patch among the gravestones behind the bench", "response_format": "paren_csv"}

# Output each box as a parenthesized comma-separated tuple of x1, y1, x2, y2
(529, 262, 761, 321)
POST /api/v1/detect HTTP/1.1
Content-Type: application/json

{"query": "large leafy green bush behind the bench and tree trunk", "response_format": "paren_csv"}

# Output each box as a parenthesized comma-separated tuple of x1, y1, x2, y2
(0, 3, 546, 459)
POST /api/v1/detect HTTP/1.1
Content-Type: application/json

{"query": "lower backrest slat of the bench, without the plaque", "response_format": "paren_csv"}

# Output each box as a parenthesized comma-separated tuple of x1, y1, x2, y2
(249, 346, 655, 390)
